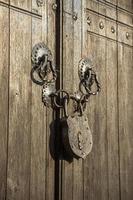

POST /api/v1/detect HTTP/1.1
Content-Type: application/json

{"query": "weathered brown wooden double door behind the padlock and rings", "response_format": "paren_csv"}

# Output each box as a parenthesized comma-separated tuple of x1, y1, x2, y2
(0, 0, 133, 200)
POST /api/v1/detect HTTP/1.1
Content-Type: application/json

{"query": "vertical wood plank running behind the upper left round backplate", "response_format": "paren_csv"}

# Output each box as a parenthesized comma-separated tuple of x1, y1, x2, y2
(30, 18, 46, 200)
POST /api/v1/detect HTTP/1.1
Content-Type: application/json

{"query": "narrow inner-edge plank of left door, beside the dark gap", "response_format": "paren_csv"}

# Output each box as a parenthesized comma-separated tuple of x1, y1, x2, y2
(43, 0, 56, 200)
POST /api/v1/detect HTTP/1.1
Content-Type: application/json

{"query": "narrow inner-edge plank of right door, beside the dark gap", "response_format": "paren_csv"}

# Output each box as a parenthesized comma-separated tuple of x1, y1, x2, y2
(62, 0, 74, 200)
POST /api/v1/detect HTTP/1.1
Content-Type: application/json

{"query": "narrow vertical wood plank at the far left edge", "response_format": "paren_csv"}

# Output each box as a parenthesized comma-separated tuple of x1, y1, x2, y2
(0, 6, 9, 200)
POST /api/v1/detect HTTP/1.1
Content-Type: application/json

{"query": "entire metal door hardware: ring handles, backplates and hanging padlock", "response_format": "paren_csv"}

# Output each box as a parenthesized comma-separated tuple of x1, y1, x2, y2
(31, 42, 100, 159)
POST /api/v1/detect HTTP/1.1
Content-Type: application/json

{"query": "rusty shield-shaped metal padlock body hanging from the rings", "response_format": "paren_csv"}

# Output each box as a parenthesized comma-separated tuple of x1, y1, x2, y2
(62, 115, 93, 159)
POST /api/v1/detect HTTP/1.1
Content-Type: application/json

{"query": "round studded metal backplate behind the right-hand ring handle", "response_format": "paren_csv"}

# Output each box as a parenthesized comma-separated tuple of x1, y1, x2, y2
(79, 58, 93, 80)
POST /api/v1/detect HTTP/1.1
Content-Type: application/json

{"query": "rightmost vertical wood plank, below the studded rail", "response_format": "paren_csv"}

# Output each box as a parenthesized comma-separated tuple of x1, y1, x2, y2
(118, 45, 133, 200)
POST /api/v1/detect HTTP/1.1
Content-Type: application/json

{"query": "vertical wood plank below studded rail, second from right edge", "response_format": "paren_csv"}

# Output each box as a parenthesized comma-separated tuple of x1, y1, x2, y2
(106, 40, 119, 200)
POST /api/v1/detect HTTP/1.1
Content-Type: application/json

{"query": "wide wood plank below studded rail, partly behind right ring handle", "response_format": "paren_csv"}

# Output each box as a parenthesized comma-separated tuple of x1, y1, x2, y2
(84, 34, 108, 200)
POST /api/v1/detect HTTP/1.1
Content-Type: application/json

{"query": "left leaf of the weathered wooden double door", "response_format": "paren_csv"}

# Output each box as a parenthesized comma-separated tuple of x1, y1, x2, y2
(0, 0, 55, 200)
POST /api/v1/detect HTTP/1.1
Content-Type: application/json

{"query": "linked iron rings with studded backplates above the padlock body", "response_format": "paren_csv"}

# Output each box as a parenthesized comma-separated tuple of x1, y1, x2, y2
(31, 43, 101, 116)
